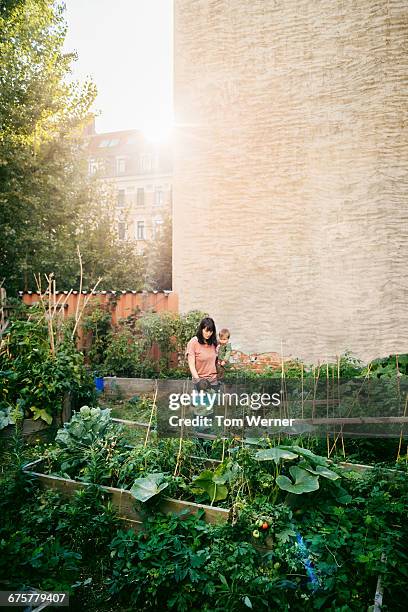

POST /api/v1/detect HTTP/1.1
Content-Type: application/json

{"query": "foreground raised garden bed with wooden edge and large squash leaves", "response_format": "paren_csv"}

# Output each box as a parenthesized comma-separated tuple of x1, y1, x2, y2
(18, 407, 407, 610)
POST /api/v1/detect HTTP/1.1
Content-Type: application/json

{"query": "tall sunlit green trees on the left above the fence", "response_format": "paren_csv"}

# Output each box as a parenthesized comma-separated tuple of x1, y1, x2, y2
(0, 0, 144, 294)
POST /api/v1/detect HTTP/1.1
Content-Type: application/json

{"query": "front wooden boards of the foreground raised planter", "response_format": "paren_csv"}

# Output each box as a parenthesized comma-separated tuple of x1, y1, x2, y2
(23, 459, 230, 531)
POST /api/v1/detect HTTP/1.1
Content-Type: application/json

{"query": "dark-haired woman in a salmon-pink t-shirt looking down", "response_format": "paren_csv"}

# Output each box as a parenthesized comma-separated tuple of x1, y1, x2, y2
(186, 317, 217, 390)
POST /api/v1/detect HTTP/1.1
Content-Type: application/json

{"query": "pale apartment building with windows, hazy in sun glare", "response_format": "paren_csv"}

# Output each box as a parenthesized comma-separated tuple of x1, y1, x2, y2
(88, 130, 172, 251)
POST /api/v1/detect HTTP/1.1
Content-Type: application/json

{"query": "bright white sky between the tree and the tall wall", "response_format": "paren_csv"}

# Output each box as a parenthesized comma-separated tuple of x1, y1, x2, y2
(65, 0, 173, 133)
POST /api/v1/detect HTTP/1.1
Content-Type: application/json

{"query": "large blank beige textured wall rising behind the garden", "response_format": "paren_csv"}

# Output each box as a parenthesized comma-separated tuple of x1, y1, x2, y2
(173, 0, 408, 362)
